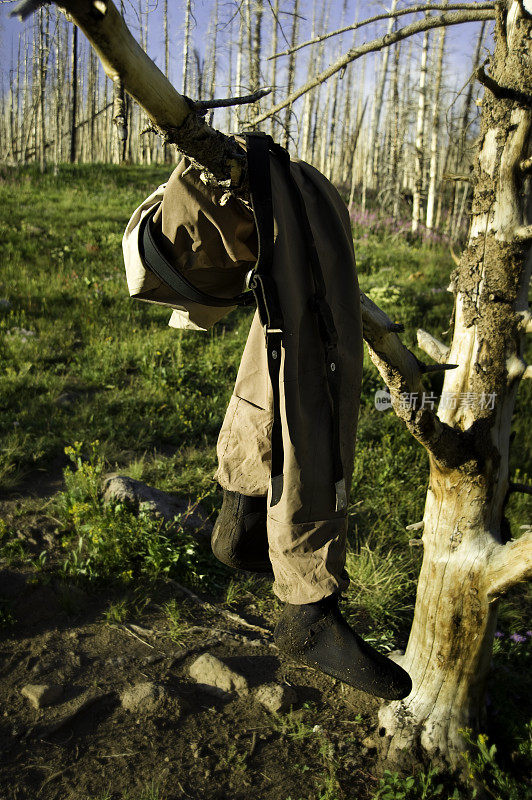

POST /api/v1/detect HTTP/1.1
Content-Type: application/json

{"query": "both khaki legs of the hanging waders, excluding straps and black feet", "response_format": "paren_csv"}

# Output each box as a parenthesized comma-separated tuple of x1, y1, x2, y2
(216, 161, 362, 604)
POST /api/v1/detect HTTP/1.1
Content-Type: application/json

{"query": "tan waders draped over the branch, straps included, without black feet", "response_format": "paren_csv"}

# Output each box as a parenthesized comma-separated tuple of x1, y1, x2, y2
(124, 134, 362, 604)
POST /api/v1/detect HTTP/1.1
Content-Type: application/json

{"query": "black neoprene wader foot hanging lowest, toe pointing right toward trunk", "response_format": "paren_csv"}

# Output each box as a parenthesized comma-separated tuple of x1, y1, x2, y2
(274, 595, 412, 700)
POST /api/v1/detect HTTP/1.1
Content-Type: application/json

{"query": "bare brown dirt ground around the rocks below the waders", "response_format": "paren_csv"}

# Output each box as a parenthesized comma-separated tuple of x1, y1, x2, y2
(0, 488, 386, 800)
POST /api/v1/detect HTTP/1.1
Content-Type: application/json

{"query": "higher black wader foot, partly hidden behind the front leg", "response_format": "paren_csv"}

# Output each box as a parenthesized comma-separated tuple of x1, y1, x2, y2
(211, 489, 273, 575)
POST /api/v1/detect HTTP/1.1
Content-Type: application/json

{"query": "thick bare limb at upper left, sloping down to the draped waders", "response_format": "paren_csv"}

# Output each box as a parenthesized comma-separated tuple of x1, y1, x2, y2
(14, 0, 248, 197)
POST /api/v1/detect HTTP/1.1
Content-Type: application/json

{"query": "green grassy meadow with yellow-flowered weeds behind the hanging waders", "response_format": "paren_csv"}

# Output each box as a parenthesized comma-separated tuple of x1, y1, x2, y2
(0, 166, 532, 800)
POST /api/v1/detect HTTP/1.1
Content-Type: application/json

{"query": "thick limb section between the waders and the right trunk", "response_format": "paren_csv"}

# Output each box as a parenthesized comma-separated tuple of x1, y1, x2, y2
(361, 294, 472, 469)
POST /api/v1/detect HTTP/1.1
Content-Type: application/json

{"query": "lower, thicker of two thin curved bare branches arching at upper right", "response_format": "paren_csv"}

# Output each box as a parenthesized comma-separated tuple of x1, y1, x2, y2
(246, 8, 495, 127)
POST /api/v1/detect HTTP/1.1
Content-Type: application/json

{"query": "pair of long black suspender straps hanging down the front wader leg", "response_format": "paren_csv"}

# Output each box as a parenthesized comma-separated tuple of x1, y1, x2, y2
(246, 133, 347, 511)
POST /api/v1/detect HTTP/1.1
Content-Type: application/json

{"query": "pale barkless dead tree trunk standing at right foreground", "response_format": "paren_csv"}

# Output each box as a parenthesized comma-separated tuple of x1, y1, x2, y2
(374, 0, 532, 765)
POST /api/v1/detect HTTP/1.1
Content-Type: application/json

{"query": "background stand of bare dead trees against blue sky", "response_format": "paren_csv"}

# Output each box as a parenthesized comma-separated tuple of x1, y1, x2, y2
(0, 0, 492, 240)
